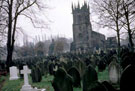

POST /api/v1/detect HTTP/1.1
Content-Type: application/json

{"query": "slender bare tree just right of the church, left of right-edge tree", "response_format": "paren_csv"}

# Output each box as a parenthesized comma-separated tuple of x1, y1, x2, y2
(94, 0, 124, 57)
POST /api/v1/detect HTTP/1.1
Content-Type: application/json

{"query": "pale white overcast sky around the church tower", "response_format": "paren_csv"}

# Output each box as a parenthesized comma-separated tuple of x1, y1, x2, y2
(18, 0, 114, 45)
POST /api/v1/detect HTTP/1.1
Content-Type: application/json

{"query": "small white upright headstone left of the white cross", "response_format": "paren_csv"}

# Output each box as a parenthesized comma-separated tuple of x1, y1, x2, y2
(9, 66, 19, 80)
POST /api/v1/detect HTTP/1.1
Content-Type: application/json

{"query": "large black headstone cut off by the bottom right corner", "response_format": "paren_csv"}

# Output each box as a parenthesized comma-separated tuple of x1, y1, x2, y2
(120, 65, 135, 91)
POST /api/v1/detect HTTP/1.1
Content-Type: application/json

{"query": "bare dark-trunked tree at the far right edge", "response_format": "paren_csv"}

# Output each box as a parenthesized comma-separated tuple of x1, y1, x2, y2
(121, 0, 135, 51)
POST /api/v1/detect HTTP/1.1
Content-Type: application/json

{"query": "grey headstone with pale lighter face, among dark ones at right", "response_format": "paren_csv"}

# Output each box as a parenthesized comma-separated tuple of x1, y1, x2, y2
(108, 59, 121, 84)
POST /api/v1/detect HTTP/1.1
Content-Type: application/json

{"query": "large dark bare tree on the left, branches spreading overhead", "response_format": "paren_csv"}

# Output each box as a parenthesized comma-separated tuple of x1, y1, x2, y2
(0, 0, 47, 68)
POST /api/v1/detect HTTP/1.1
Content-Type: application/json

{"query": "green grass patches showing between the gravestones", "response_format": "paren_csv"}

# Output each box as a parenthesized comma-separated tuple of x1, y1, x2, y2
(0, 69, 108, 91)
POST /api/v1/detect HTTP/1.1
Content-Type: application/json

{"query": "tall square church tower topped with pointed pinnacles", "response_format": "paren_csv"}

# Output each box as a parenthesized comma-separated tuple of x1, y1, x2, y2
(72, 3, 92, 50)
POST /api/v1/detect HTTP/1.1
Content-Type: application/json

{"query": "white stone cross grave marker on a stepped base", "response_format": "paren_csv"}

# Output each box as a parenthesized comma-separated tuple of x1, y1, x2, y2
(21, 66, 33, 91)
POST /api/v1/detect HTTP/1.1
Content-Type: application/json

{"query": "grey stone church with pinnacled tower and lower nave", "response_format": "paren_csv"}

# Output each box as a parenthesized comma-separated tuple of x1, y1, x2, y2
(70, 3, 106, 52)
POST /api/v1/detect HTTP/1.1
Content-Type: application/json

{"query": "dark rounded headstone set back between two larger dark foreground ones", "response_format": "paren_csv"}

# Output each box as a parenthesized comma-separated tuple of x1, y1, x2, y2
(68, 67, 81, 87)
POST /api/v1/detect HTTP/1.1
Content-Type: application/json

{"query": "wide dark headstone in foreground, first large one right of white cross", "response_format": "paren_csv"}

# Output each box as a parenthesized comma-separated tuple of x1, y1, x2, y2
(52, 68, 73, 91)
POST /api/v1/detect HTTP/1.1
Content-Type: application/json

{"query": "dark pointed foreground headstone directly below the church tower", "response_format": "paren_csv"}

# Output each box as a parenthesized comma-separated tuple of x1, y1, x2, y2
(83, 65, 98, 91)
